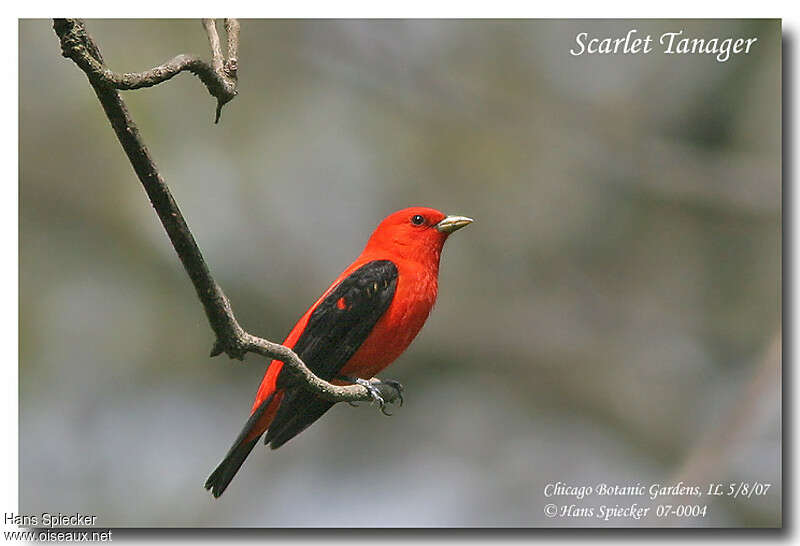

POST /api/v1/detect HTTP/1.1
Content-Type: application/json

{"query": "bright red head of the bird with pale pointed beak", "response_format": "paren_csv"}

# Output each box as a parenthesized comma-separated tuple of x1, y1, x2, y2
(365, 207, 472, 264)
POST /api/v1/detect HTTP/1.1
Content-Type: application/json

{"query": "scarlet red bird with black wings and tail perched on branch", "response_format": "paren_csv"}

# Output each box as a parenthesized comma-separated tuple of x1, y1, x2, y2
(205, 207, 472, 497)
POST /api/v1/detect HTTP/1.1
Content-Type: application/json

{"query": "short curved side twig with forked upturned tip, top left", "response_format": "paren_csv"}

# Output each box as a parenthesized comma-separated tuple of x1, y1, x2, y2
(59, 19, 239, 123)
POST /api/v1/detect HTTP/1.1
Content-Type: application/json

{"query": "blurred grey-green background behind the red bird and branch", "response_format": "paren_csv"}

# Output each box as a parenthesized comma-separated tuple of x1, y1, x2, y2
(19, 20, 781, 526)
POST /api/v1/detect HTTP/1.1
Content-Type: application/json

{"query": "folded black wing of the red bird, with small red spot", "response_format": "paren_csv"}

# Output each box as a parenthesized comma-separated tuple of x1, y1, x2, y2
(264, 260, 397, 449)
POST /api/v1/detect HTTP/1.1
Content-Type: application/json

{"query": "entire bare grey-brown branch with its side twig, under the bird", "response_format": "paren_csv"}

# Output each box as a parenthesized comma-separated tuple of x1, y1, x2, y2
(53, 19, 402, 408)
